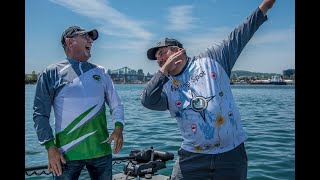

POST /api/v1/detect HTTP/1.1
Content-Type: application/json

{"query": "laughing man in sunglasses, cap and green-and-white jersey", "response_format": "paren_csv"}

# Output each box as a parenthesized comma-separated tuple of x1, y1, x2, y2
(33, 26, 125, 180)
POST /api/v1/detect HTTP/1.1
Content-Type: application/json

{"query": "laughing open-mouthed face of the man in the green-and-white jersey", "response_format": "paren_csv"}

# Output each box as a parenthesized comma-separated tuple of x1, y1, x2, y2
(68, 33, 93, 61)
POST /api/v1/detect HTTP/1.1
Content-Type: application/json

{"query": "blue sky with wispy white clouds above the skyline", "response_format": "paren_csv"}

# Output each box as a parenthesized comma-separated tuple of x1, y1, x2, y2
(25, 0, 295, 74)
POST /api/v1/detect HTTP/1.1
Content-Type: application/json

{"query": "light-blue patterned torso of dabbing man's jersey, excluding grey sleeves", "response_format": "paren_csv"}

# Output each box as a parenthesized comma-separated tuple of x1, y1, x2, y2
(164, 57, 247, 154)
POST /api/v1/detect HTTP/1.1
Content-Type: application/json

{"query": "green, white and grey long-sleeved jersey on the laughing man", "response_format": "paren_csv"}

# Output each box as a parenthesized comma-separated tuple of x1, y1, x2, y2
(33, 59, 125, 160)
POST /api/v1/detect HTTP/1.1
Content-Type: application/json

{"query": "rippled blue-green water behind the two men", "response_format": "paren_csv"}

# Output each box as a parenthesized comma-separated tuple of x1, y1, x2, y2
(25, 84, 295, 180)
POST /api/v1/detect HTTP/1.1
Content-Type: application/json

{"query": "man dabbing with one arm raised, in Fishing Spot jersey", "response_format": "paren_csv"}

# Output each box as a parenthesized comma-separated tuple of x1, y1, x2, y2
(141, 0, 275, 180)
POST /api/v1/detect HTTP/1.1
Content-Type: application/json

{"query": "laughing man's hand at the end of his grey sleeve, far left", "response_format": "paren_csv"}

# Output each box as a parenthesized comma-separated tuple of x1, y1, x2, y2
(48, 146, 66, 176)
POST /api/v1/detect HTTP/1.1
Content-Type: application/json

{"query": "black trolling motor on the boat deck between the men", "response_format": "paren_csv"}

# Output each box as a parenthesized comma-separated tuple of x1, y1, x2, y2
(123, 147, 174, 176)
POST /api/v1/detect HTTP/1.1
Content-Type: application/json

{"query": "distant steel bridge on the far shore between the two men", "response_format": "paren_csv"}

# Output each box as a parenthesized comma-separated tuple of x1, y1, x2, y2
(108, 67, 153, 83)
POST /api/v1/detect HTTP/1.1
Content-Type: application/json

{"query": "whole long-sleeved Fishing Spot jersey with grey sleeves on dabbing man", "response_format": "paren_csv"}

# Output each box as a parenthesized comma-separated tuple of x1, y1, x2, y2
(141, 8, 267, 154)
